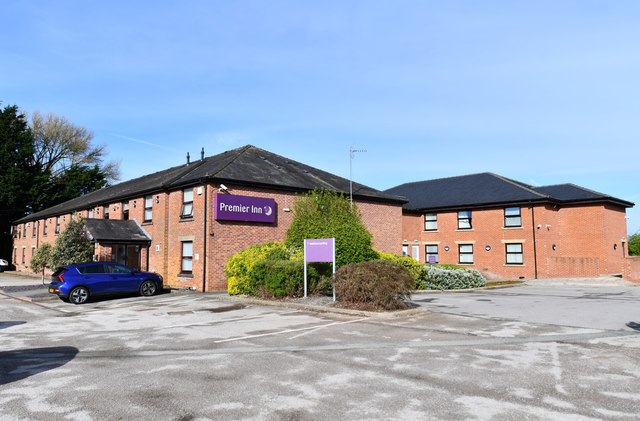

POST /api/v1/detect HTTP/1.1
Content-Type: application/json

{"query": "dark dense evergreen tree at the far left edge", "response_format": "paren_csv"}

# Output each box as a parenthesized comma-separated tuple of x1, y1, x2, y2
(0, 105, 37, 259)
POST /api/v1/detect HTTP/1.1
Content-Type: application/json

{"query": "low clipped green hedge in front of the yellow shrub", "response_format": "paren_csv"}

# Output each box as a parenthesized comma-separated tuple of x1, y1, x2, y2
(249, 259, 318, 298)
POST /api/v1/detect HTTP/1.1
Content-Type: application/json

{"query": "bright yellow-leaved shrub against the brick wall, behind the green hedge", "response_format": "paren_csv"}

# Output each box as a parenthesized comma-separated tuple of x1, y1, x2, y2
(225, 242, 289, 295)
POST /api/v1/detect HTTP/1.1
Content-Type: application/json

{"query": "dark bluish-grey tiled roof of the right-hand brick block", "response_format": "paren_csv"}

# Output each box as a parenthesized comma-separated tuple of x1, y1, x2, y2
(385, 172, 633, 211)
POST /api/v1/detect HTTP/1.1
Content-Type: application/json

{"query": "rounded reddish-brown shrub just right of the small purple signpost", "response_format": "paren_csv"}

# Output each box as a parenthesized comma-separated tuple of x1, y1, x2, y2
(334, 260, 415, 310)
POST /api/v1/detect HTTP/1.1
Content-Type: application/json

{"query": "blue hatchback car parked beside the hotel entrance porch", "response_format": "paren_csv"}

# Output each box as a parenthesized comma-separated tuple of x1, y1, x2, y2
(49, 262, 163, 304)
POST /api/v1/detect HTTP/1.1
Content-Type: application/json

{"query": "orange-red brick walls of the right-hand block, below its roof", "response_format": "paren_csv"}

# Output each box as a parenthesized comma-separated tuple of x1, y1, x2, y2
(402, 205, 626, 278)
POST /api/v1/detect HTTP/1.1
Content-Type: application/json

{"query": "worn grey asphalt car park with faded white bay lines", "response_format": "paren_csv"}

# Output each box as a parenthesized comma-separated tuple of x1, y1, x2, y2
(0, 272, 640, 420)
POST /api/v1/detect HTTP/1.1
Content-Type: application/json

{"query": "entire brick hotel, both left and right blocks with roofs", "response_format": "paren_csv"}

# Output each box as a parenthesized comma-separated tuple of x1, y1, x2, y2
(12, 145, 640, 291)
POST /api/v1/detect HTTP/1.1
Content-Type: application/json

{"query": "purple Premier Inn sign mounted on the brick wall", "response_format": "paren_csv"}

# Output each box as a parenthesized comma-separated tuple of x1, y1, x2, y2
(213, 194, 276, 224)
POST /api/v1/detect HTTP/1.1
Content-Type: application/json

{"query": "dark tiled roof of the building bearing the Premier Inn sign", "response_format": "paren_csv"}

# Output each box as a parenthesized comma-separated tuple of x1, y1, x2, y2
(17, 145, 404, 223)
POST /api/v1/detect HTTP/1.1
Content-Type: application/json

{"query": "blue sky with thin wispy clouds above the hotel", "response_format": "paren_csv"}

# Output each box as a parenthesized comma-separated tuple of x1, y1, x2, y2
(0, 0, 640, 233)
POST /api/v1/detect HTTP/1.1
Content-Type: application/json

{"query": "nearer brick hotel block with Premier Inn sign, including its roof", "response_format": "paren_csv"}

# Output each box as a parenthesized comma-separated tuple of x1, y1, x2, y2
(12, 145, 405, 291)
